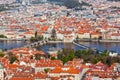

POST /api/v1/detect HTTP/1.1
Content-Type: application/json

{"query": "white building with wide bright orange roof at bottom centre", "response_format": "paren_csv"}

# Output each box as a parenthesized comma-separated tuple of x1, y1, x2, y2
(48, 66, 80, 80)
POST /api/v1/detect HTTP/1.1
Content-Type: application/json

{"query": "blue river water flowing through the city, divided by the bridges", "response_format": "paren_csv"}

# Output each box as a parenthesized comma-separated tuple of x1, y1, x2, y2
(0, 41, 120, 54)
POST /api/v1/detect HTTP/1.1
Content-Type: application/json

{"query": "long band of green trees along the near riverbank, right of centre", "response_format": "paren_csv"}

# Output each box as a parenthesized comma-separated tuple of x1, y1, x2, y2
(58, 49, 120, 66)
